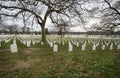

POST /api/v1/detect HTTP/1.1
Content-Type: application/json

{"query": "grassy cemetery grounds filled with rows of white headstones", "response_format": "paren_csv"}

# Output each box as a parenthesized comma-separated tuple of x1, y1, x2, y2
(0, 35, 120, 78)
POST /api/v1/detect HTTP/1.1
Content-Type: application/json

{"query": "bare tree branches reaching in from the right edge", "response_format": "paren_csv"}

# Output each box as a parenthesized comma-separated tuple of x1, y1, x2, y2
(88, 0, 120, 32)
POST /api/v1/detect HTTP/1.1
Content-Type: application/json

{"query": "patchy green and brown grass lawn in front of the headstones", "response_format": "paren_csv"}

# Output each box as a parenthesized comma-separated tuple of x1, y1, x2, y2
(0, 38, 120, 78)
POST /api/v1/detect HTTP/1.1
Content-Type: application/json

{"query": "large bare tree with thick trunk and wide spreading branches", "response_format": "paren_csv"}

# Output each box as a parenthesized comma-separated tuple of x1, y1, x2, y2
(0, 0, 85, 42)
